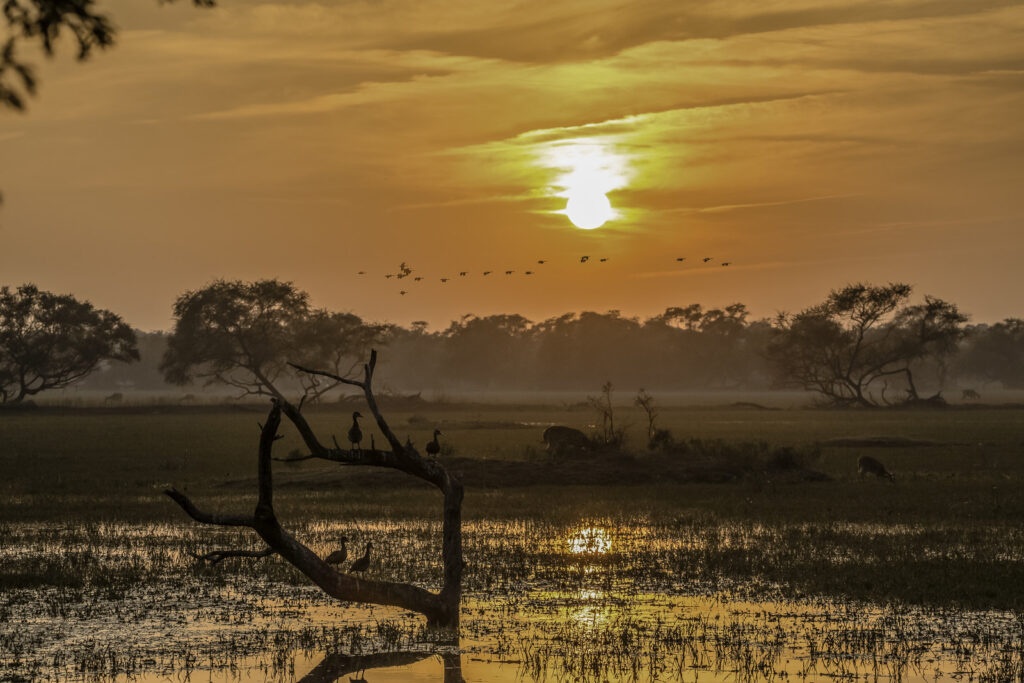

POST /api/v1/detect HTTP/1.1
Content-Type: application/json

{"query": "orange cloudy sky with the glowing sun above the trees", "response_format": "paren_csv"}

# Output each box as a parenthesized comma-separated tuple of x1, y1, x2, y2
(0, 0, 1024, 330)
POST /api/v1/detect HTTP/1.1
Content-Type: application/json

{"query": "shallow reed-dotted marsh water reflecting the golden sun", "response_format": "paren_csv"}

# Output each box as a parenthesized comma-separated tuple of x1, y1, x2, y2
(0, 517, 1024, 682)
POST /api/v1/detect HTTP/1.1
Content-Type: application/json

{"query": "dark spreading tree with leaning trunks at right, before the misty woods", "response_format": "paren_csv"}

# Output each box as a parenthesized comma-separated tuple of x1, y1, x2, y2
(768, 283, 967, 407)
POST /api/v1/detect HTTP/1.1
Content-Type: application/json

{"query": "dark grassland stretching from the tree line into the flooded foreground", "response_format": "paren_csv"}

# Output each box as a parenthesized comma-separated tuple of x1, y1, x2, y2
(0, 397, 1024, 680)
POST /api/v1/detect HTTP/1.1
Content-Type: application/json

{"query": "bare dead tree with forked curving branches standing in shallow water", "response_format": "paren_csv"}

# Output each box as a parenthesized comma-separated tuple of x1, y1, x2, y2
(164, 351, 463, 629)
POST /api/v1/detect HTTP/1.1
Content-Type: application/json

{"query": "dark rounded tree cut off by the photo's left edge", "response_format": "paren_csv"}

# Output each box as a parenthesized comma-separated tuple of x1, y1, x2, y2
(0, 285, 139, 403)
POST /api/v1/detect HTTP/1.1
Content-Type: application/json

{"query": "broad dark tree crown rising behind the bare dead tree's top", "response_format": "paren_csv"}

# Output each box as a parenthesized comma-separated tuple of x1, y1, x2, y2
(161, 280, 380, 399)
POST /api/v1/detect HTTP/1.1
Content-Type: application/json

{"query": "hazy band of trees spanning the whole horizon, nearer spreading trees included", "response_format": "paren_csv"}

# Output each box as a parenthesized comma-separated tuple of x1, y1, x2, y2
(0, 280, 1024, 407)
